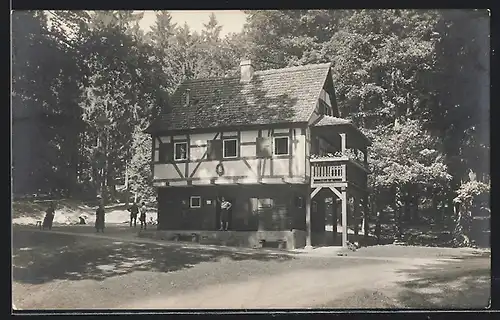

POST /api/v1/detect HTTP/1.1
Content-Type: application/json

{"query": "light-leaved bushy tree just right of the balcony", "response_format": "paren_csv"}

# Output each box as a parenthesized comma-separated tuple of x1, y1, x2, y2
(369, 120, 452, 236)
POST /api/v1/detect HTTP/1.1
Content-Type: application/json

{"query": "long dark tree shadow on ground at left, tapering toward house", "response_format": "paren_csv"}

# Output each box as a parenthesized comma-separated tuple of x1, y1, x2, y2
(13, 231, 293, 284)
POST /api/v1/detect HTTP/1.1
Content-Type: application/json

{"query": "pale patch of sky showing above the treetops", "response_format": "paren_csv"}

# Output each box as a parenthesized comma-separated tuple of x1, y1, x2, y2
(140, 10, 246, 37)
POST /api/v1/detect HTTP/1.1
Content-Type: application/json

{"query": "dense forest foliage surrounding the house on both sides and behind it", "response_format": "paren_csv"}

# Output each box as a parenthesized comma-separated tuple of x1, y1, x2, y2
(13, 9, 489, 236)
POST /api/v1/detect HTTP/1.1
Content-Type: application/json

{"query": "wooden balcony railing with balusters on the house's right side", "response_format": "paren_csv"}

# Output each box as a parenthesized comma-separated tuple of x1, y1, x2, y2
(309, 156, 369, 188)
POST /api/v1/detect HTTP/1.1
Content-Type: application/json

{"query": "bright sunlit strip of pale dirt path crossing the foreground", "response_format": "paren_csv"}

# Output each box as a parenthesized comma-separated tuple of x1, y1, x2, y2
(123, 259, 435, 309)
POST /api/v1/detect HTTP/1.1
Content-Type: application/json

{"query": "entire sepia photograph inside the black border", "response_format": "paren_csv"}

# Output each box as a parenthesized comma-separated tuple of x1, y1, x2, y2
(11, 9, 491, 312)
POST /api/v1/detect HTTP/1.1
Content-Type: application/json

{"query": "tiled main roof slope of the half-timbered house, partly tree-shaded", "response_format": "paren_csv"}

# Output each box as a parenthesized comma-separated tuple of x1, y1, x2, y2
(146, 63, 331, 132)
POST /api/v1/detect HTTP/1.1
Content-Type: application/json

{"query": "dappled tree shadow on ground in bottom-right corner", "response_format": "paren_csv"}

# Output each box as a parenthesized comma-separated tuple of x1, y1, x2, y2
(397, 256, 491, 309)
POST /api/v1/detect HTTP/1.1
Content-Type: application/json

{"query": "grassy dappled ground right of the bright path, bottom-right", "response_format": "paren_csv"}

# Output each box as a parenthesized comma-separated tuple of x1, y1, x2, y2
(318, 254, 491, 310)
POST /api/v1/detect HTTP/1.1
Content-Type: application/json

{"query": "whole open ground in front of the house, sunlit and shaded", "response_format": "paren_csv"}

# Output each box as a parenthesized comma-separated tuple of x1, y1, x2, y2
(13, 230, 489, 309)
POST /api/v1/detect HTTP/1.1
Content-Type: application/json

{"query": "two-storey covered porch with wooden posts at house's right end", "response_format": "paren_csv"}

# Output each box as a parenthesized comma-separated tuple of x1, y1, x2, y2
(306, 116, 371, 247)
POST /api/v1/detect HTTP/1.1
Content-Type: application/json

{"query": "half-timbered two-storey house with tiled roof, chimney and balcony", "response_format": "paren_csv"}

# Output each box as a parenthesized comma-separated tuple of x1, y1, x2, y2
(146, 60, 370, 248)
